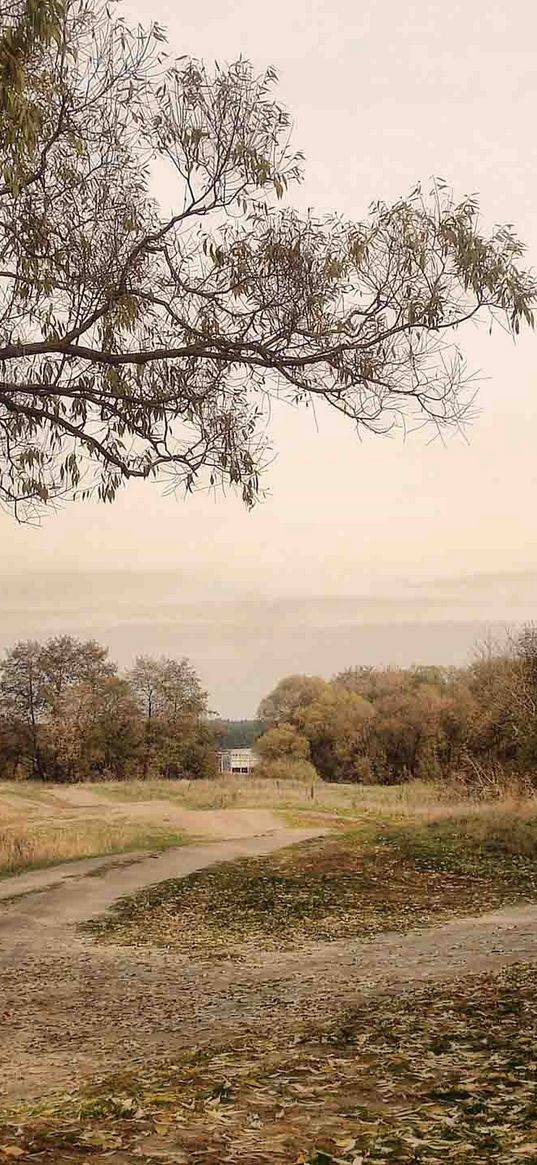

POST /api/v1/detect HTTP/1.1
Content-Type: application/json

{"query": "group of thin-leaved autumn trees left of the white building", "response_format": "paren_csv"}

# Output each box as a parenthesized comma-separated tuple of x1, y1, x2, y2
(0, 635, 217, 782)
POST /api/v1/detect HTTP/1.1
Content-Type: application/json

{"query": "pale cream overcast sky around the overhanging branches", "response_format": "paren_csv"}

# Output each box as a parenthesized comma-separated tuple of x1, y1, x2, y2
(0, 0, 537, 715)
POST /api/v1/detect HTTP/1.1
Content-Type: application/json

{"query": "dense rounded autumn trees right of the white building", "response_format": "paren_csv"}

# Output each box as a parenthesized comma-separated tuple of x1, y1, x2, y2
(256, 626, 537, 786)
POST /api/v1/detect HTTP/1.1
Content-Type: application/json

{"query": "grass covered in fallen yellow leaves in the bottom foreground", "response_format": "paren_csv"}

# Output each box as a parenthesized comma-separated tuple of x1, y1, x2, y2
(0, 966, 537, 1165)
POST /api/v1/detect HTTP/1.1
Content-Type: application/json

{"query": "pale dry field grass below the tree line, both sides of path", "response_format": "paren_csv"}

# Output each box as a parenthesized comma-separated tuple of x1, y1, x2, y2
(0, 776, 537, 875)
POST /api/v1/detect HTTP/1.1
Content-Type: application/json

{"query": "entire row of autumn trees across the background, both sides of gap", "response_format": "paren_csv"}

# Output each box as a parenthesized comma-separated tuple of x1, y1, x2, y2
(0, 624, 537, 788)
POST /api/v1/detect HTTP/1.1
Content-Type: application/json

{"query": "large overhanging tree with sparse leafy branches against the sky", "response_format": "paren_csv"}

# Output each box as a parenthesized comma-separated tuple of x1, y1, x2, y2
(0, 0, 536, 517)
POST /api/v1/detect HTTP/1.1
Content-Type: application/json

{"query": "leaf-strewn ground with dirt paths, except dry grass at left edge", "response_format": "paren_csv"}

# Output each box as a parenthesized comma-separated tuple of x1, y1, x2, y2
(0, 789, 537, 1165)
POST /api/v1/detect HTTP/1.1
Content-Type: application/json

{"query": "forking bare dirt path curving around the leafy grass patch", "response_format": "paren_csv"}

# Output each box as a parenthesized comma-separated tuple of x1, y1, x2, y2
(0, 829, 537, 1097)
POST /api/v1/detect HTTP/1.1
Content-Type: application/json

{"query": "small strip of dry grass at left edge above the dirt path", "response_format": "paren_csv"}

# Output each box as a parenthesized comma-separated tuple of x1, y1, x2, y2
(0, 818, 184, 877)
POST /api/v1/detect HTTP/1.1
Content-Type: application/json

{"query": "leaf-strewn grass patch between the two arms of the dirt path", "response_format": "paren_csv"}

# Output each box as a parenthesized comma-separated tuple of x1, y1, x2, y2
(84, 810, 537, 959)
